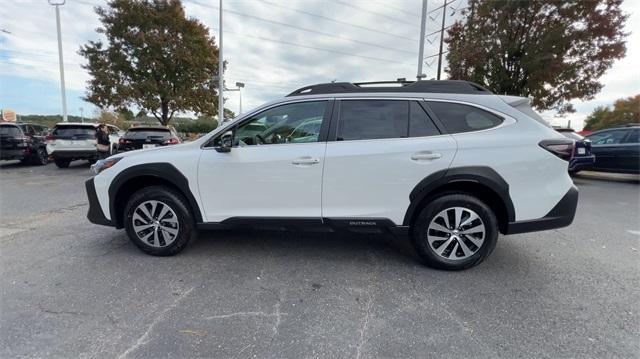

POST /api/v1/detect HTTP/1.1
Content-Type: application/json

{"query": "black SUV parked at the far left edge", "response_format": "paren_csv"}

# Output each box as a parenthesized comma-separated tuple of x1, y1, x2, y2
(0, 123, 49, 165)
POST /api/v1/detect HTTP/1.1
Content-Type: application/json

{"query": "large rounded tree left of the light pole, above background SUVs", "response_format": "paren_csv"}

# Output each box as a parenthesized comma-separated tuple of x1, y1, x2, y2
(80, 0, 218, 125)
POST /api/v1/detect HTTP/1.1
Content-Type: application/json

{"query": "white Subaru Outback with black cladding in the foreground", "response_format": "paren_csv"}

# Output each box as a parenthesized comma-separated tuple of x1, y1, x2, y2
(86, 81, 578, 269)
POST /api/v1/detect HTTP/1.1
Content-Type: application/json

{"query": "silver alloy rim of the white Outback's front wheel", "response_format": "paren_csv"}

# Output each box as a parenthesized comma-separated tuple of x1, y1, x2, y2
(131, 200, 179, 248)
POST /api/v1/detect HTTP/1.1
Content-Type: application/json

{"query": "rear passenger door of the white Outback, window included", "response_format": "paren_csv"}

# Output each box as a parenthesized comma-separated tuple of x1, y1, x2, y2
(322, 99, 456, 225)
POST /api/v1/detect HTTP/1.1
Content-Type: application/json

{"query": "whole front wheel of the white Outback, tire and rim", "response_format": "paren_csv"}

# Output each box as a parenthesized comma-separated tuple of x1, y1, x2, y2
(124, 186, 194, 256)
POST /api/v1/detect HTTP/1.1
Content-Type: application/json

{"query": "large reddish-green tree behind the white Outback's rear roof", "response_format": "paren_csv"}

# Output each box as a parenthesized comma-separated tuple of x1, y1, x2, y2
(446, 0, 627, 112)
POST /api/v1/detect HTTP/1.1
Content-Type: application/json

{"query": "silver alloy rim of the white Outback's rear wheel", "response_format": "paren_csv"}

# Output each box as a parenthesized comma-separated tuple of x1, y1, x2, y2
(427, 207, 485, 260)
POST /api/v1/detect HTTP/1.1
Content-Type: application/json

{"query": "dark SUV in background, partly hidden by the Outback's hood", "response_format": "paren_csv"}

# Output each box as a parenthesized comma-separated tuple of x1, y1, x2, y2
(118, 126, 181, 152)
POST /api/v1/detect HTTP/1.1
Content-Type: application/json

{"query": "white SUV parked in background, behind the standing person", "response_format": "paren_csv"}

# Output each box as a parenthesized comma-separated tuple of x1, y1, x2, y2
(47, 122, 121, 168)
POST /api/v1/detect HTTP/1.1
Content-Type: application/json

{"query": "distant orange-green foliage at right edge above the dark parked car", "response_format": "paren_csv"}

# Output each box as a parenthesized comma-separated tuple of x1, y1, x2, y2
(584, 95, 640, 131)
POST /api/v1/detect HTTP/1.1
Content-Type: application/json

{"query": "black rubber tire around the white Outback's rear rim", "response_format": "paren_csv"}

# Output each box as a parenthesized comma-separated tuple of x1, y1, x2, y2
(411, 193, 498, 270)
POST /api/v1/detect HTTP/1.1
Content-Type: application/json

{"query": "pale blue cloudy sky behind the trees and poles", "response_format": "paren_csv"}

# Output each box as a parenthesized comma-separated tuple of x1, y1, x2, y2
(0, 0, 640, 129)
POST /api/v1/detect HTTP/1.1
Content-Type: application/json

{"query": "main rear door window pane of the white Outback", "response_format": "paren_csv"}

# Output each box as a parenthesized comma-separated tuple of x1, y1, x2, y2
(338, 100, 409, 141)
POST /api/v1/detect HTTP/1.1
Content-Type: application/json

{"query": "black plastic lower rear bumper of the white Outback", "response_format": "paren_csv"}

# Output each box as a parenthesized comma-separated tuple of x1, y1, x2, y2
(505, 186, 578, 234)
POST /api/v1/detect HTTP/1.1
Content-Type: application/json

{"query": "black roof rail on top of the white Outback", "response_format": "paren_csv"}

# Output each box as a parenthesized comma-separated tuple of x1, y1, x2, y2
(287, 80, 492, 97)
